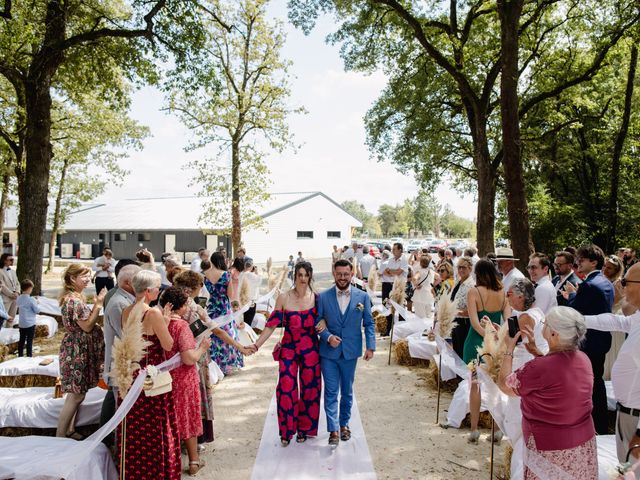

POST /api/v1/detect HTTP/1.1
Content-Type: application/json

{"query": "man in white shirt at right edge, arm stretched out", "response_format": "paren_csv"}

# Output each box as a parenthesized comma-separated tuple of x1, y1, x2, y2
(584, 264, 640, 462)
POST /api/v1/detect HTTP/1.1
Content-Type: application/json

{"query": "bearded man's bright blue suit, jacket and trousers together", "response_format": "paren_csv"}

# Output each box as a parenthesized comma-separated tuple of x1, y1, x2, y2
(317, 286, 376, 432)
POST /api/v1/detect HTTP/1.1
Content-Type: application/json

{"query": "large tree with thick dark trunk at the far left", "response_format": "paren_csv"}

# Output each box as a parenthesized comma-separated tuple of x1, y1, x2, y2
(0, 0, 209, 293)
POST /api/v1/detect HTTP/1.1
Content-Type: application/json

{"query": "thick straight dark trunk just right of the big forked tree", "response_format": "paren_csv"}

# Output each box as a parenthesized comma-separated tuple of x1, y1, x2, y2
(498, 0, 533, 271)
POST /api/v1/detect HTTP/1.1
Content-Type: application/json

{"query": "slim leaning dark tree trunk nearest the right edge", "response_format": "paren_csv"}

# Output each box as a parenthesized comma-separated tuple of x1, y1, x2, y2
(605, 44, 638, 252)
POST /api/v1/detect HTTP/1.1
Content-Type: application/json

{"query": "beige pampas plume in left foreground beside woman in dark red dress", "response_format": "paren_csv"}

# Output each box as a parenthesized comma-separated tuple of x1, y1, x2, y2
(111, 301, 151, 398)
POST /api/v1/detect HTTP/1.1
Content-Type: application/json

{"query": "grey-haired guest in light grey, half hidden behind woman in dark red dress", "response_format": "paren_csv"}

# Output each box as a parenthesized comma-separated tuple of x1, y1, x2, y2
(100, 260, 140, 446)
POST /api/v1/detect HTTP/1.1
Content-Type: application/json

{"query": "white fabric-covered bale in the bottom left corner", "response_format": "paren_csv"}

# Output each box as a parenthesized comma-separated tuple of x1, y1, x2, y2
(0, 436, 118, 480)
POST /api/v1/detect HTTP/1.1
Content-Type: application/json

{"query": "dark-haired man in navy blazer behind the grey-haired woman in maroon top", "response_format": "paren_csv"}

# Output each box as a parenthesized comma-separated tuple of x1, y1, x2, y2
(564, 245, 614, 435)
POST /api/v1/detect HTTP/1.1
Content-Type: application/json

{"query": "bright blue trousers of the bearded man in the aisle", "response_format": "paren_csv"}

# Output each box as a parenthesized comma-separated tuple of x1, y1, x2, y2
(320, 357, 358, 432)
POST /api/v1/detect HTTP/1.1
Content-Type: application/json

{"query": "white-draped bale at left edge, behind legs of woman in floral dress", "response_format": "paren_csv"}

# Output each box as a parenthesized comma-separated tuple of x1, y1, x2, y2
(0, 387, 107, 428)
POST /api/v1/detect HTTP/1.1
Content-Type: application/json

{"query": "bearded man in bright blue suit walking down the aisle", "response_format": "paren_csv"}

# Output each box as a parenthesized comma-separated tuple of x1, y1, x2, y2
(317, 260, 376, 448)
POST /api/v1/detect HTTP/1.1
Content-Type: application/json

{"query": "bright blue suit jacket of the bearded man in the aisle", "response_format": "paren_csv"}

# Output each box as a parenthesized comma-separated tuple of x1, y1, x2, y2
(317, 287, 376, 360)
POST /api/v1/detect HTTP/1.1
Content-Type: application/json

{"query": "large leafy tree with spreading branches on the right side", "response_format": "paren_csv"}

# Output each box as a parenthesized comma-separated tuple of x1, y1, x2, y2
(289, 0, 640, 260)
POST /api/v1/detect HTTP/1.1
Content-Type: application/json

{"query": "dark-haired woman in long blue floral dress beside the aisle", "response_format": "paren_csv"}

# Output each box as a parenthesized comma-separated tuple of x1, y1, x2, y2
(203, 252, 244, 375)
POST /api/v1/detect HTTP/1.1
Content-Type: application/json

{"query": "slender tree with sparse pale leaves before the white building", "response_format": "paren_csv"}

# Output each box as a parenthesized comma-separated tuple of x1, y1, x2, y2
(169, 0, 302, 252)
